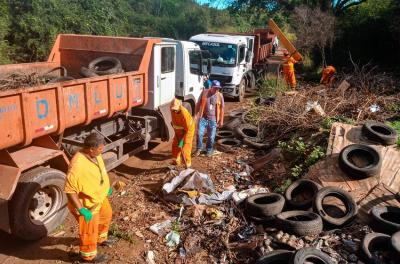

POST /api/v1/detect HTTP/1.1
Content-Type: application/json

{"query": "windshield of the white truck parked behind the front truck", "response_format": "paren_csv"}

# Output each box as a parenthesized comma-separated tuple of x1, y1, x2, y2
(196, 41, 237, 67)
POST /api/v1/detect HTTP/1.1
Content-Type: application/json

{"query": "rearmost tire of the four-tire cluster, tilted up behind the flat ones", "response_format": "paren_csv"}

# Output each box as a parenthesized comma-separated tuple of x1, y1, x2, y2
(285, 179, 322, 209)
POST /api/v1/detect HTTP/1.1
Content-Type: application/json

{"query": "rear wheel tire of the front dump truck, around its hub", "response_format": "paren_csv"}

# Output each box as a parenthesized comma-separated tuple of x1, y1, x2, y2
(9, 167, 68, 240)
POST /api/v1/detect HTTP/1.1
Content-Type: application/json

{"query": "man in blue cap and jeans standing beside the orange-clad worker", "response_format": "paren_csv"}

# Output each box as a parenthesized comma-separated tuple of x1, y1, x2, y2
(195, 80, 224, 156)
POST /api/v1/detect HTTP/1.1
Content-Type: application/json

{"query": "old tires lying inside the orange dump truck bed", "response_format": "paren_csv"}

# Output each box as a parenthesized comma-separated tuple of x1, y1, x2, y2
(80, 56, 124, 77)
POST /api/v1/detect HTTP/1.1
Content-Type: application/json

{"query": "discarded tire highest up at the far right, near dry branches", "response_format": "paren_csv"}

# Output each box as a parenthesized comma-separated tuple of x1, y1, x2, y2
(361, 121, 397, 145)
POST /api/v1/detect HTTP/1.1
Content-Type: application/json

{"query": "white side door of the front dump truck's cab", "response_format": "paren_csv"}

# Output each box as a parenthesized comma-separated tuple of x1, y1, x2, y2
(154, 43, 176, 106)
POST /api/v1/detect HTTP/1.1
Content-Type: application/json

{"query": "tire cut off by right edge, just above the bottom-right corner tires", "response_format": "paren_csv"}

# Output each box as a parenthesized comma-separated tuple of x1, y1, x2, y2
(371, 205, 400, 235)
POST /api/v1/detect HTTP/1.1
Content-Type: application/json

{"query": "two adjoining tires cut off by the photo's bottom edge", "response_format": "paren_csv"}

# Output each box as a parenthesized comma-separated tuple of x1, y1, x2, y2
(256, 247, 334, 264)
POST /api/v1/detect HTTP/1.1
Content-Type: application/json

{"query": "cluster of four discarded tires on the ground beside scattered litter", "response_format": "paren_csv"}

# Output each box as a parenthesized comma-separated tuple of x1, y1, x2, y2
(245, 179, 357, 237)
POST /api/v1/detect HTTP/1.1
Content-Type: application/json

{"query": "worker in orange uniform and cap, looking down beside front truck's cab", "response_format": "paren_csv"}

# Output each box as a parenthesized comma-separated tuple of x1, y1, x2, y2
(170, 98, 195, 168)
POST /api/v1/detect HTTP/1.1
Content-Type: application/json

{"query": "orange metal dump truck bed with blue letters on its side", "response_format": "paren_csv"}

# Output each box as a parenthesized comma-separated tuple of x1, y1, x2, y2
(0, 35, 160, 152)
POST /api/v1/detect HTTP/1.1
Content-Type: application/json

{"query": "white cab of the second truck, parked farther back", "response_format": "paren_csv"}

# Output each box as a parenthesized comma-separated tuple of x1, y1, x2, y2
(190, 33, 255, 101)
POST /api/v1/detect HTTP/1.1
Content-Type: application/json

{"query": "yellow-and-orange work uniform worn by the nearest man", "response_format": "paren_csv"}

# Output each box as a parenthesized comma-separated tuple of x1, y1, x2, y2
(64, 152, 112, 260)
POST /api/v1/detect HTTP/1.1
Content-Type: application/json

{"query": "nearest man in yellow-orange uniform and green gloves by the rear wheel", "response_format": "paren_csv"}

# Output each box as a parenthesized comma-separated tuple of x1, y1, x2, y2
(64, 133, 115, 263)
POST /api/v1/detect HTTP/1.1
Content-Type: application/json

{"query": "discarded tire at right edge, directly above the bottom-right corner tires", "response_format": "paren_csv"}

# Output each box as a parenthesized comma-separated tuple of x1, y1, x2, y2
(371, 206, 400, 235)
